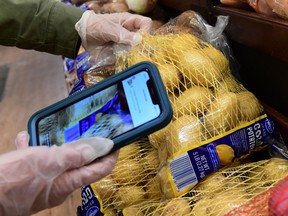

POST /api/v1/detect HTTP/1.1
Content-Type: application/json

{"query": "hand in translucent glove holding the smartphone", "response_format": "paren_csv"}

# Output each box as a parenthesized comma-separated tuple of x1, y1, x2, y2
(0, 132, 118, 216)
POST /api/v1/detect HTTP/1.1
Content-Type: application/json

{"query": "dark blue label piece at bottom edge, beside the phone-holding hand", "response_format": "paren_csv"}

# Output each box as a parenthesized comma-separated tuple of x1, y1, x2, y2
(81, 185, 104, 216)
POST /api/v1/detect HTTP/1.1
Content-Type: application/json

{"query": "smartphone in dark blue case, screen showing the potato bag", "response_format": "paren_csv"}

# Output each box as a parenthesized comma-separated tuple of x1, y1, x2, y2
(28, 62, 173, 150)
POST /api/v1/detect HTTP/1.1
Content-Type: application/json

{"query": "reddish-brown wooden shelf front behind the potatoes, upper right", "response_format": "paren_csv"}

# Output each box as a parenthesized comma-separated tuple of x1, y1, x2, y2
(214, 5, 288, 62)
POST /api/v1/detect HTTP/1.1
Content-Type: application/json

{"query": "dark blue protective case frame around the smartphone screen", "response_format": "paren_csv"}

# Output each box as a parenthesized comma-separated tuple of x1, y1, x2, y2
(28, 62, 173, 150)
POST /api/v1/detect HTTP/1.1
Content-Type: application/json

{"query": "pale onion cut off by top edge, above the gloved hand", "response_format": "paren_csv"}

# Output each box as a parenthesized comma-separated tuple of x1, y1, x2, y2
(126, 0, 157, 14)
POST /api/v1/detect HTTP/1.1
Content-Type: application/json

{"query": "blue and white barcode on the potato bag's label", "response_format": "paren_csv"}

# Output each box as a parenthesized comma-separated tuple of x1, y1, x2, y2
(170, 153, 198, 192)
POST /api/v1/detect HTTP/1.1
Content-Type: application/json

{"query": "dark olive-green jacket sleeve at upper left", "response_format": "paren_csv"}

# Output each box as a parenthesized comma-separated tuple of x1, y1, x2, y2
(0, 0, 84, 58)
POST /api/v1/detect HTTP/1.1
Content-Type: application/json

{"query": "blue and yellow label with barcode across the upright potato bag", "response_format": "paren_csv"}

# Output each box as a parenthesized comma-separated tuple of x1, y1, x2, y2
(169, 115, 278, 195)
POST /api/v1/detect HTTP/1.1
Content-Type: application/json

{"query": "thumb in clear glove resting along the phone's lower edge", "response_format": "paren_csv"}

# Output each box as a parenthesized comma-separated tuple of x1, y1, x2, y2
(23, 137, 114, 180)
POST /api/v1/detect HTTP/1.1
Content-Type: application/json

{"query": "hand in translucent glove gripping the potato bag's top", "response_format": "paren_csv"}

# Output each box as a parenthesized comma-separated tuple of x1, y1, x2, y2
(75, 10, 152, 51)
